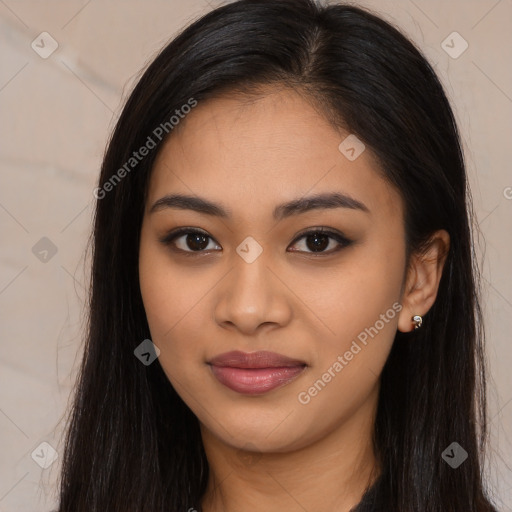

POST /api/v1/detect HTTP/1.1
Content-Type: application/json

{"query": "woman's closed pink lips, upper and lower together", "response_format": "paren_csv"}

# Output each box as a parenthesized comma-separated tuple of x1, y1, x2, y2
(209, 351, 307, 395)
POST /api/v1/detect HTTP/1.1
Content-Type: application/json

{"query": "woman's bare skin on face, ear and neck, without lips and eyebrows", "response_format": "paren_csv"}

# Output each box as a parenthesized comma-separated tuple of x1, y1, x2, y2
(139, 88, 449, 512)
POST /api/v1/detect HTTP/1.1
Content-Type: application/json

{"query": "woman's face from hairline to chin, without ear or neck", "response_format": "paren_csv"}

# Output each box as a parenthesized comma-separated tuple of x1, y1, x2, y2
(139, 90, 406, 452)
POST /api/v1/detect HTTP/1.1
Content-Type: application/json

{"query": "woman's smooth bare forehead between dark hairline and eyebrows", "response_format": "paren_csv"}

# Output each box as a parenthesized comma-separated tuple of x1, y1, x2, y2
(148, 89, 401, 222)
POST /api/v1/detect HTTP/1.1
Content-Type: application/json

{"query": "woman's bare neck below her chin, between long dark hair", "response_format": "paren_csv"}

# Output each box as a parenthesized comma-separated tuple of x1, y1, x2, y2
(201, 386, 379, 512)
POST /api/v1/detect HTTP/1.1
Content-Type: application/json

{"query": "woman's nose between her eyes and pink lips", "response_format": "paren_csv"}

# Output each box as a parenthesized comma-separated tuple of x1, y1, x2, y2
(214, 249, 293, 335)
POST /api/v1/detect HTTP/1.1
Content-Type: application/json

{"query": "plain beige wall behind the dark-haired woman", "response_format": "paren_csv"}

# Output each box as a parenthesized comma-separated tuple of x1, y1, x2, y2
(0, 0, 512, 512)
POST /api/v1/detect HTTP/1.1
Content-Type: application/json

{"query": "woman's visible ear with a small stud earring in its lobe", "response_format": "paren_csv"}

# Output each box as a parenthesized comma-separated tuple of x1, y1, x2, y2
(398, 229, 450, 332)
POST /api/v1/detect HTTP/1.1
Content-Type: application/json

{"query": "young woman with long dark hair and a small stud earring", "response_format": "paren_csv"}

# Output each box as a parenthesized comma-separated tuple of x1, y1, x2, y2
(59, 0, 495, 512)
